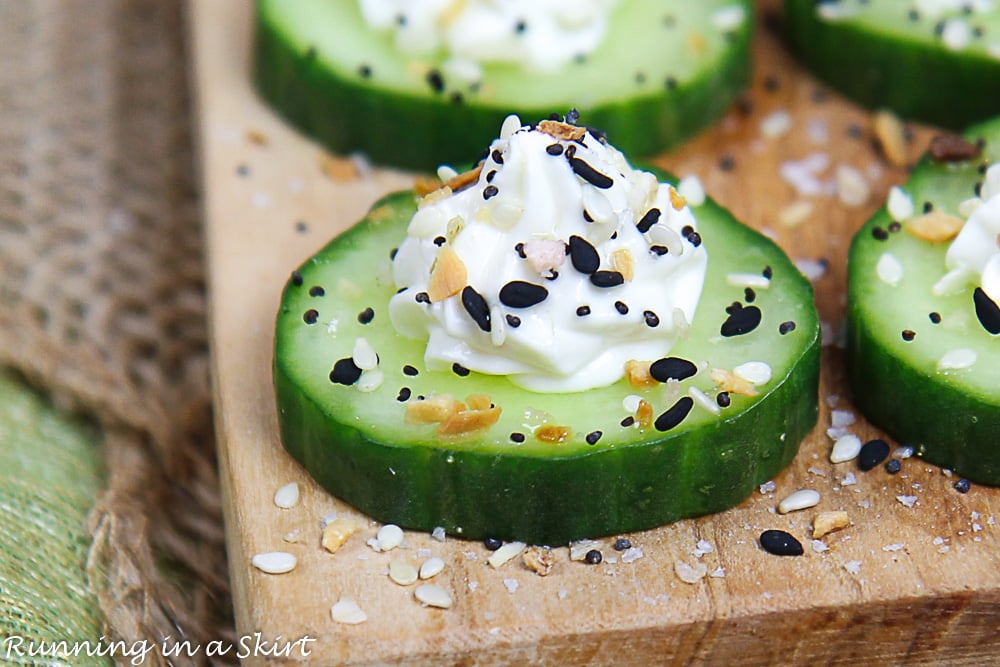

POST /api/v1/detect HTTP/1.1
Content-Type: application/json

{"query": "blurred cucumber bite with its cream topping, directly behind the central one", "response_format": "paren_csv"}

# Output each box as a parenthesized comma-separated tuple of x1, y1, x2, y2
(253, 0, 753, 169)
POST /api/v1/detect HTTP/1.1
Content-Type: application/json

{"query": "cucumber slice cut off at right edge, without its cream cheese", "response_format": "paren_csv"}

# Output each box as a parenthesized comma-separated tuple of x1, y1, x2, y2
(846, 119, 1000, 485)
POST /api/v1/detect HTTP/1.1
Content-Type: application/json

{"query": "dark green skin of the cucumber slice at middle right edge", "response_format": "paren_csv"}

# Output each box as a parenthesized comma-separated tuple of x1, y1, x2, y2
(845, 118, 1000, 486)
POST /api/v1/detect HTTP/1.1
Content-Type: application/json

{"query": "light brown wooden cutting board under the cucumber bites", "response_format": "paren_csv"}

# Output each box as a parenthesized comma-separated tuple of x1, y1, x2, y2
(190, 0, 1000, 665)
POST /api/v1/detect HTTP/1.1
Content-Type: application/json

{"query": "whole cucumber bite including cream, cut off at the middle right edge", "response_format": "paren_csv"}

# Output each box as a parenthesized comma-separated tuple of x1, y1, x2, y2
(847, 119, 1000, 485)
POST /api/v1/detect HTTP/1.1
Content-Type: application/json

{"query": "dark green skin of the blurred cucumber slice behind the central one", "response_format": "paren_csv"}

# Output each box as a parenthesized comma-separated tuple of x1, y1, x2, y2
(252, 2, 752, 171)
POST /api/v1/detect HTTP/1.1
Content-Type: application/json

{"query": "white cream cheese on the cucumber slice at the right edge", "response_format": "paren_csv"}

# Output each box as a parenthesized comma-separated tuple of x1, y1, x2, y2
(934, 165, 1000, 303)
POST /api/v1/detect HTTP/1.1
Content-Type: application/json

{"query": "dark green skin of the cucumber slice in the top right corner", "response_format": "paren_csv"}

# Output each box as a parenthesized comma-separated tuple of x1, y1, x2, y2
(784, 0, 1000, 130)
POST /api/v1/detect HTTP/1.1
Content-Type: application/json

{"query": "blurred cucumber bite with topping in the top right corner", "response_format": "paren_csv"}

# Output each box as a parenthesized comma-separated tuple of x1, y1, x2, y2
(784, 0, 1000, 129)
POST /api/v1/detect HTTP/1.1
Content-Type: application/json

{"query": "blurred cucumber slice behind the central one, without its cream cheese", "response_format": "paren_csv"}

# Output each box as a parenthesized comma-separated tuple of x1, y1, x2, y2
(253, 0, 753, 169)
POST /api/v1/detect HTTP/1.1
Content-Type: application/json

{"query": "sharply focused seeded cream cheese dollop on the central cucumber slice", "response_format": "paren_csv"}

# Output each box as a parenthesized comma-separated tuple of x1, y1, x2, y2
(389, 116, 708, 392)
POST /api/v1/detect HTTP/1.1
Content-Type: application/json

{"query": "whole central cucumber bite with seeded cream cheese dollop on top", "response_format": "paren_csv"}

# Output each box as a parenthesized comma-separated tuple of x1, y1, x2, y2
(274, 116, 820, 544)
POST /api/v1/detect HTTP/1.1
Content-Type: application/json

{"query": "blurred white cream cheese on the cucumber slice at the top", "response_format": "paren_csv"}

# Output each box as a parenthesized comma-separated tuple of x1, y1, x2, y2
(359, 0, 619, 75)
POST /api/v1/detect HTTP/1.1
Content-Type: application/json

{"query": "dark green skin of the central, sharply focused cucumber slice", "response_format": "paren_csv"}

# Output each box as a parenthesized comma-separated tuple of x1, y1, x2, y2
(273, 193, 820, 545)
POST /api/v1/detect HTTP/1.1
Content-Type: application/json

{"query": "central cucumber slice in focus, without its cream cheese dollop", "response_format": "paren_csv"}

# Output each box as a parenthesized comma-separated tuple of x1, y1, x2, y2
(274, 178, 820, 544)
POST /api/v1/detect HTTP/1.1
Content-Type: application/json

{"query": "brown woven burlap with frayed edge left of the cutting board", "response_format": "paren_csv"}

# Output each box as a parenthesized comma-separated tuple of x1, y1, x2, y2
(0, 0, 232, 664)
